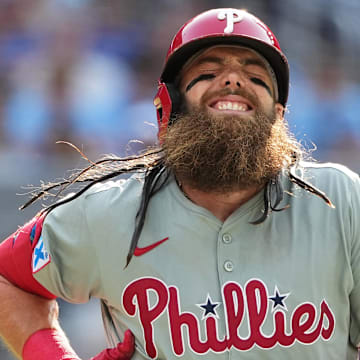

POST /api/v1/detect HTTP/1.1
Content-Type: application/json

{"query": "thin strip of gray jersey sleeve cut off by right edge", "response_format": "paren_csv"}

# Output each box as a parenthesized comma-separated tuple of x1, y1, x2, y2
(344, 177, 360, 347)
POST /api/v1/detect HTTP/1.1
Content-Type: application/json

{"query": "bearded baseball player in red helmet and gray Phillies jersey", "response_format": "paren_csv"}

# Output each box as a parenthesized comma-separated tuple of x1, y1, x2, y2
(0, 8, 360, 360)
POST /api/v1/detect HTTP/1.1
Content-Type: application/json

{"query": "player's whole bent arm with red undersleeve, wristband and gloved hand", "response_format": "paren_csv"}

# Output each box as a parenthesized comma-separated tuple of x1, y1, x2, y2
(0, 215, 134, 360)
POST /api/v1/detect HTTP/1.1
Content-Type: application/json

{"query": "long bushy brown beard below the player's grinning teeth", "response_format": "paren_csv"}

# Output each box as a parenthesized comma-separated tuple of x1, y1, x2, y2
(163, 89, 300, 193)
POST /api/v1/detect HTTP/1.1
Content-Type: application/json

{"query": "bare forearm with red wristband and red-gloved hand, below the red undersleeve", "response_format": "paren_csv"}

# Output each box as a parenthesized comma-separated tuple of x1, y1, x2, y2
(0, 276, 134, 360)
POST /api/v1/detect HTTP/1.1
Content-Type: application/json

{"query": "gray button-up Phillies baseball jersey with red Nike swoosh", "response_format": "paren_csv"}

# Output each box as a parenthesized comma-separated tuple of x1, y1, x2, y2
(33, 164, 360, 360)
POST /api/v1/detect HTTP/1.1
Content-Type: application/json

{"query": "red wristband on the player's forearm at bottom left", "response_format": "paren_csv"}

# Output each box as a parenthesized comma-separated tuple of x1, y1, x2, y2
(22, 329, 80, 360)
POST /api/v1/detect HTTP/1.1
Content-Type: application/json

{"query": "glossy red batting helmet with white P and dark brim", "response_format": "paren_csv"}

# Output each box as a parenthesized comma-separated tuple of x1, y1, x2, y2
(154, 8, 289, 138)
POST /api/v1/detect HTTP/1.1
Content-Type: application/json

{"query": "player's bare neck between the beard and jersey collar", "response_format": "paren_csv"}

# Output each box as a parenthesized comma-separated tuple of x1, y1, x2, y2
(180, 183, 263, 222)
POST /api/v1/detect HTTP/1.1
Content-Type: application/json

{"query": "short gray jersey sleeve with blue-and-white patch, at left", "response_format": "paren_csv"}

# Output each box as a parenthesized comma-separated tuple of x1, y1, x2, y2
(32, 195, 101, 303)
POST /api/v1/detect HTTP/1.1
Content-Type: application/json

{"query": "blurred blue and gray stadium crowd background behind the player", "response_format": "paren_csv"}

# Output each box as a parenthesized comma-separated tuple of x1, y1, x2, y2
(0, 0, 360, 360)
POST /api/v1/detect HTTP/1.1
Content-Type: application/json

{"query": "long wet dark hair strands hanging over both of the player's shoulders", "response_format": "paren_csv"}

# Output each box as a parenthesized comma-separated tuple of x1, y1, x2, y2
(20, 145, 333, 266)
